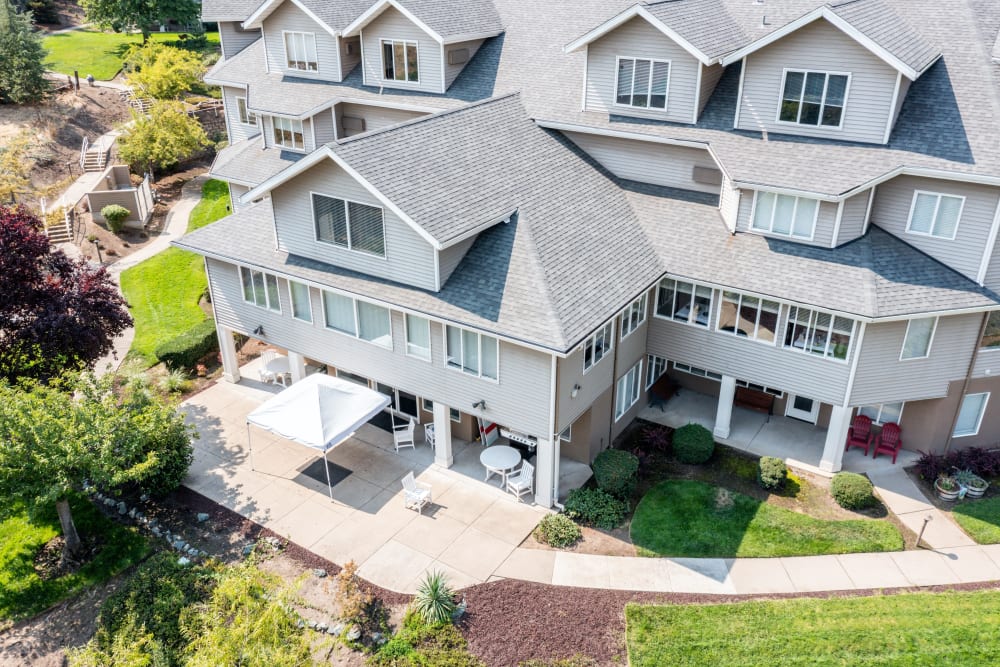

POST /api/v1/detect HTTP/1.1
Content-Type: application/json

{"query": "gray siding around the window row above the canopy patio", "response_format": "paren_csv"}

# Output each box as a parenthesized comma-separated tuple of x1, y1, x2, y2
(208, 259, 552, 437)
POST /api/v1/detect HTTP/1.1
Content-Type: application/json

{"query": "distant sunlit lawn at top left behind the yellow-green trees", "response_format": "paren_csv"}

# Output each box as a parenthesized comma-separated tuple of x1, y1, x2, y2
(42, 30, 219, 81)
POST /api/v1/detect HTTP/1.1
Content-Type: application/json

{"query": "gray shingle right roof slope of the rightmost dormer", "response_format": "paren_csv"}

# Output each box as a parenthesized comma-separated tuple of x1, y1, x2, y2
(830, 0, 941, 72)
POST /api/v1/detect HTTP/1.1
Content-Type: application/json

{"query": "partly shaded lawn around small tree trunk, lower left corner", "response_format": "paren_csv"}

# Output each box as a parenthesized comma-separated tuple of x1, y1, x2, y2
(0, 497, 150, 625)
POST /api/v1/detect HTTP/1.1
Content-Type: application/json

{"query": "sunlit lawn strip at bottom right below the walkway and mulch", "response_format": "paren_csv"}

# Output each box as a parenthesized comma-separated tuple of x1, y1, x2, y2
(625, 591, 1000, 667)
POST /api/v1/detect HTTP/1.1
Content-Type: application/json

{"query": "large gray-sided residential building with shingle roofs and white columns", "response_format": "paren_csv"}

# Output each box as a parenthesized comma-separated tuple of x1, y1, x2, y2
(184, 0, 1000, 506)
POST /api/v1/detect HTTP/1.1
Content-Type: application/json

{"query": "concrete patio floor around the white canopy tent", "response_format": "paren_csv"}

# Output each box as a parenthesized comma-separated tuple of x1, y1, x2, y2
(182, 360, 577, 592)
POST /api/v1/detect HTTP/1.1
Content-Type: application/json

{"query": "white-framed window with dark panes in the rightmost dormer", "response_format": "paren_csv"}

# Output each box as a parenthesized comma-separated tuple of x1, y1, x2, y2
(778, 69, 851, 128)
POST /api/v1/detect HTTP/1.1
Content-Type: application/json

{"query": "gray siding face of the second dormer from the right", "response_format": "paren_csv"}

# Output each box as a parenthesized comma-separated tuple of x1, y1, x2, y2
(586, 17, 701, 123)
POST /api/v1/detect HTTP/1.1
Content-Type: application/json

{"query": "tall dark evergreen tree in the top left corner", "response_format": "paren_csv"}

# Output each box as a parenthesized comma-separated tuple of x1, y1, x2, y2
(0, 0, 49, 104)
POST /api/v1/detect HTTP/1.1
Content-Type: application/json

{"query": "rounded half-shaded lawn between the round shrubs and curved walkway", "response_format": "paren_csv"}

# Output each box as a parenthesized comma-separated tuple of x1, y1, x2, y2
(631, 480, 903, 558)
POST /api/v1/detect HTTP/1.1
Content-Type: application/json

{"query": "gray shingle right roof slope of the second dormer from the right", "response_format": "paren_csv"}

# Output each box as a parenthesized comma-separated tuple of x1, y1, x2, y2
(645, 0, 750, 58)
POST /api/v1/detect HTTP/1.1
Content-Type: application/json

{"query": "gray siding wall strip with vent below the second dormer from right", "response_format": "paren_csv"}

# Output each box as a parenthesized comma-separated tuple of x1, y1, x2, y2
(564, 132, 719, 194)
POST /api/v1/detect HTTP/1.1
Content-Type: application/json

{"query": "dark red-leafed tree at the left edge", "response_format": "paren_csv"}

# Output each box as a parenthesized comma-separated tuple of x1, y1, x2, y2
(0, 206, 132, 381)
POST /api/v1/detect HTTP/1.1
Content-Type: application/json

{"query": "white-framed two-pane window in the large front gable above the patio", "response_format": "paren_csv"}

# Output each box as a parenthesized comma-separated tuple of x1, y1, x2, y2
(312, 192, 385, 257)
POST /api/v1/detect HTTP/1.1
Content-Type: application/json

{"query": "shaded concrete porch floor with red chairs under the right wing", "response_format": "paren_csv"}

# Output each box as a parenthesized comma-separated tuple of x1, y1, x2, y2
(639, 389, 917, 476)
